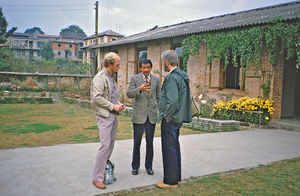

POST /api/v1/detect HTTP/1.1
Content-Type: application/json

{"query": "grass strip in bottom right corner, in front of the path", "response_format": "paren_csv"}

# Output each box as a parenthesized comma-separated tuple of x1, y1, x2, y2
(123, 158, 300, 196)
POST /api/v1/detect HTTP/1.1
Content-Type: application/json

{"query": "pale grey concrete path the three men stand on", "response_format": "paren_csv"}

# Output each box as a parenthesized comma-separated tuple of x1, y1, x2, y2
(0, 129, 300, 196)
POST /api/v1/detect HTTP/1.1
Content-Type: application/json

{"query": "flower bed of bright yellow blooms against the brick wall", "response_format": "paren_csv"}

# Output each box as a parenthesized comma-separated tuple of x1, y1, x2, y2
(213, 97, 274, 125)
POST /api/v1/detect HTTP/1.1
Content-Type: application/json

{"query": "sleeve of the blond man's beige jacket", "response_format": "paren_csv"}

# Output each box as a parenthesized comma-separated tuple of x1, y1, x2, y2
(91, 75, 114, 111)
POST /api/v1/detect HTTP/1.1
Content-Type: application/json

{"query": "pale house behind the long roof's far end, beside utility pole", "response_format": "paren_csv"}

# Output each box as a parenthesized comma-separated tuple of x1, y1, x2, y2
(82, 30, 124, 63)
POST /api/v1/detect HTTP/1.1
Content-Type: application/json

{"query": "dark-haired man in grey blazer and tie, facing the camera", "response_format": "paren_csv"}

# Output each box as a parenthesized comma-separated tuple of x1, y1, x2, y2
(127, 59, 161, 175)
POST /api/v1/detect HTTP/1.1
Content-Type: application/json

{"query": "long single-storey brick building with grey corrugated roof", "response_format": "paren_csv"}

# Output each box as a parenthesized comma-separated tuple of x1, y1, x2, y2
(89, 1, 300, 119)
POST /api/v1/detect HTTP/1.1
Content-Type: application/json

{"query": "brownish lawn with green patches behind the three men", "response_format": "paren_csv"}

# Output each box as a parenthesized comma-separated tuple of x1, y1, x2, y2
(0, 102, 201, 149)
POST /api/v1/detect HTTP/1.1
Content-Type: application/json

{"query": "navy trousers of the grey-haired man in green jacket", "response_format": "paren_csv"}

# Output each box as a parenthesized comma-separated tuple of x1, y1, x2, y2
(161, 118, 182, 185)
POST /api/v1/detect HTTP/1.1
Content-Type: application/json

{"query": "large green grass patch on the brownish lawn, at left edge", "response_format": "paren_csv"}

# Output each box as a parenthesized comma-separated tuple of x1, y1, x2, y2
(0, 123, 61, 134)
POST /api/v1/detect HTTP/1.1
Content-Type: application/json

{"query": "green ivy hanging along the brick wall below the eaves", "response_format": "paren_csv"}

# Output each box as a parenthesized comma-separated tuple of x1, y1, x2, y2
(182, 19, 300, 71)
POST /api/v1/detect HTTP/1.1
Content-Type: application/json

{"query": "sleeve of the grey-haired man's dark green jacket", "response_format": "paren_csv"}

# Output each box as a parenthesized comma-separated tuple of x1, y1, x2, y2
(164, 77, 178, 122)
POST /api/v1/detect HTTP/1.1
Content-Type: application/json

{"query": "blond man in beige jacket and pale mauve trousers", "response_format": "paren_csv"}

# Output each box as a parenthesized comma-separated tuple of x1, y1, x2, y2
(91, 52, 125, 189)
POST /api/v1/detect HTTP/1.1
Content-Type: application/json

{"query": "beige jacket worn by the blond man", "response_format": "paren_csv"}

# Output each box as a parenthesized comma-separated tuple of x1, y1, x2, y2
(91, 68, 120, 117)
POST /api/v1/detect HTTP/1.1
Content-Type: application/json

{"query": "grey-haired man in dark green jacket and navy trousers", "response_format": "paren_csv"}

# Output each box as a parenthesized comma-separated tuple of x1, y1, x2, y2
(156, 50, 192, 188)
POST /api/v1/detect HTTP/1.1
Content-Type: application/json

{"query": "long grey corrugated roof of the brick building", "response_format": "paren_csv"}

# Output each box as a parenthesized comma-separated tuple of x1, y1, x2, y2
(91, 1, 300, 48)
